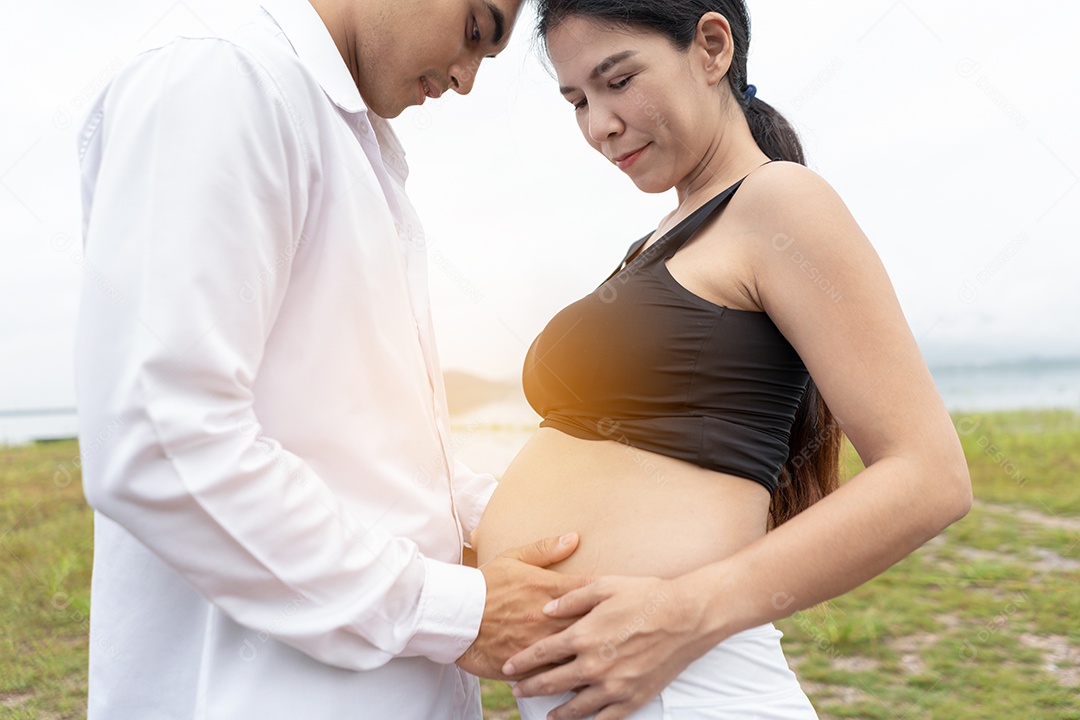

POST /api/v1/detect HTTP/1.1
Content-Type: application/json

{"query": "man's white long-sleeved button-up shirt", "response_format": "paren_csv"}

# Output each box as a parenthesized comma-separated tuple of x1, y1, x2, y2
(76, 0, 495, 720)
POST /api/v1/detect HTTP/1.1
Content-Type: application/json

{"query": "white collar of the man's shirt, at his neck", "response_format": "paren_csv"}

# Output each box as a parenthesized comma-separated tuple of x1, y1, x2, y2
(262, 0, 367, 112)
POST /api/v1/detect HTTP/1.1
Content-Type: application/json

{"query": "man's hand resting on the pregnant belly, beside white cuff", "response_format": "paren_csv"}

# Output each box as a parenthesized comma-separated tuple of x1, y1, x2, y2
(457, 533, 593, 680)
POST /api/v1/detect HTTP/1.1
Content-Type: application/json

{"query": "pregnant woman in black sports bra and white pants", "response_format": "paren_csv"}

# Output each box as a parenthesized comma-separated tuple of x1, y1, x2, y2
(473, 0, 971, 720)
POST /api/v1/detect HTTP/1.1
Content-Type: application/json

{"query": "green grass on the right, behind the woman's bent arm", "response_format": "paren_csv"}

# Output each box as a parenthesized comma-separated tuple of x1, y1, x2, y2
(756, 411, 1080, 720)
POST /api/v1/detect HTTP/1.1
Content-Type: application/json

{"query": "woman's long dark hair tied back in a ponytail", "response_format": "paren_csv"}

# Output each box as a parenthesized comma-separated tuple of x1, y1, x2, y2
(537, 0, 843, 528)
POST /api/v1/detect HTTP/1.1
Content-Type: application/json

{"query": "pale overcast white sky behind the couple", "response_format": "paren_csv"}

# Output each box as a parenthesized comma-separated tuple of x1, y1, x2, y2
(0, 0, 1080, 410)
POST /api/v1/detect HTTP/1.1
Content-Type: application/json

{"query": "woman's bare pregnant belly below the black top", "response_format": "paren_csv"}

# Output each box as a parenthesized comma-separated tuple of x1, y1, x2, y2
(472, 427, 769, 578)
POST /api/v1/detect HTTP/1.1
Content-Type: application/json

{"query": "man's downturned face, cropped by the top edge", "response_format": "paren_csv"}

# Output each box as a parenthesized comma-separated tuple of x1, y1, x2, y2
(354, 0, 522, 118)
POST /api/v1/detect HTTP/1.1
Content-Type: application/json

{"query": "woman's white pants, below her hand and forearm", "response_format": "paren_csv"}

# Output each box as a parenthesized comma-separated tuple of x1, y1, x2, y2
(517, 623, 818, 720)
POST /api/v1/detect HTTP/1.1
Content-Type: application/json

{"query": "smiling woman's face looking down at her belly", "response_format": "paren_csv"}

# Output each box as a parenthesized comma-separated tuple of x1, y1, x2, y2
(548, 16, 723, 192)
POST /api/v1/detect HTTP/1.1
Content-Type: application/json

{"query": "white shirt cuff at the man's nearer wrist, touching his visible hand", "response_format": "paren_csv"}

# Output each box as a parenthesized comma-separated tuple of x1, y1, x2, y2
(402, 557, 487, 665)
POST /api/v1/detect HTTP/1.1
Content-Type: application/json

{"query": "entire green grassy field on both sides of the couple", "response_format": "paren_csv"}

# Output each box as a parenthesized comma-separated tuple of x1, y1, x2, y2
(0, 411, 1080, 720)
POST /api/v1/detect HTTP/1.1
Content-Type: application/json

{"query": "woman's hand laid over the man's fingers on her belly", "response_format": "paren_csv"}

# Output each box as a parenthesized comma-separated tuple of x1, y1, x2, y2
(502, 576, 715, 718)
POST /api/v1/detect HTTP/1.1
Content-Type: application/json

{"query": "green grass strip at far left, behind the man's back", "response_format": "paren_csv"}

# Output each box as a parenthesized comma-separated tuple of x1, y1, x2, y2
(0, 441, 93, 720)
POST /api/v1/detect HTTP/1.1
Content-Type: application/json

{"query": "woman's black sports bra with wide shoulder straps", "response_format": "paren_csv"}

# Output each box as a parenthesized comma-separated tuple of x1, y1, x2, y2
(523, 174, 809, 493)
